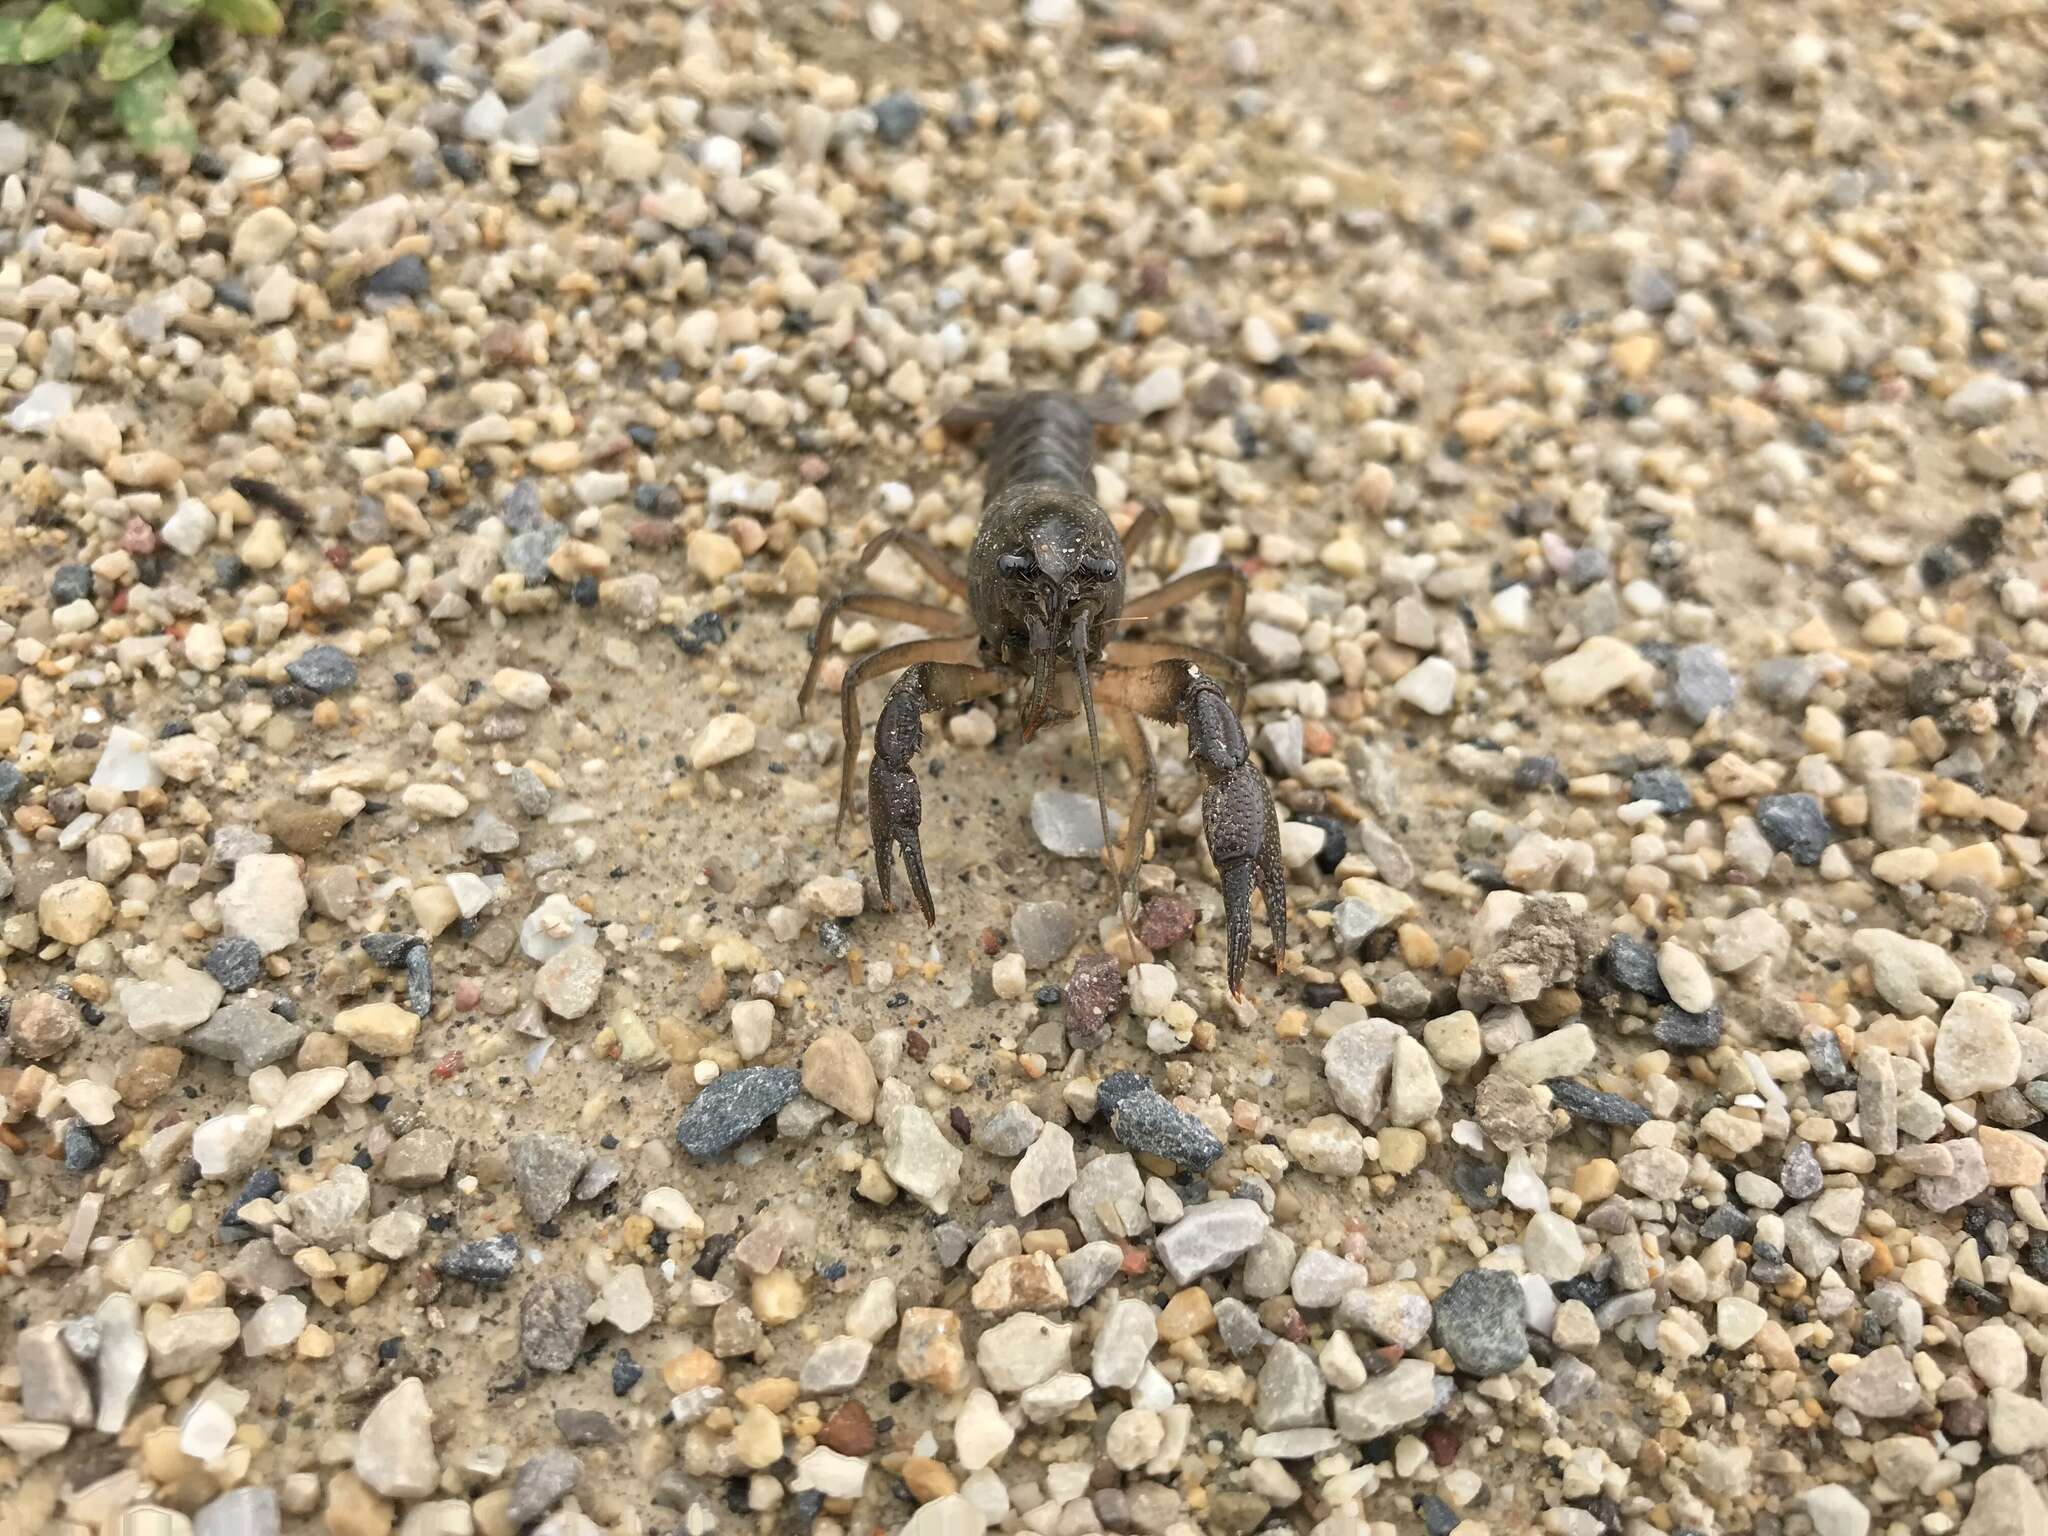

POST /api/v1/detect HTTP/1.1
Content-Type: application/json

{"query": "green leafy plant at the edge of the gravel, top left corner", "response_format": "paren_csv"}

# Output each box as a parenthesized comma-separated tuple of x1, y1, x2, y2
(0, 0, 292, 150)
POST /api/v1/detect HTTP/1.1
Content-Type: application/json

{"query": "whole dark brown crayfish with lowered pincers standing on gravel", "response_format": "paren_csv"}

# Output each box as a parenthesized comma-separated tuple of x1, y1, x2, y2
(797, 391, 1286, 995)
